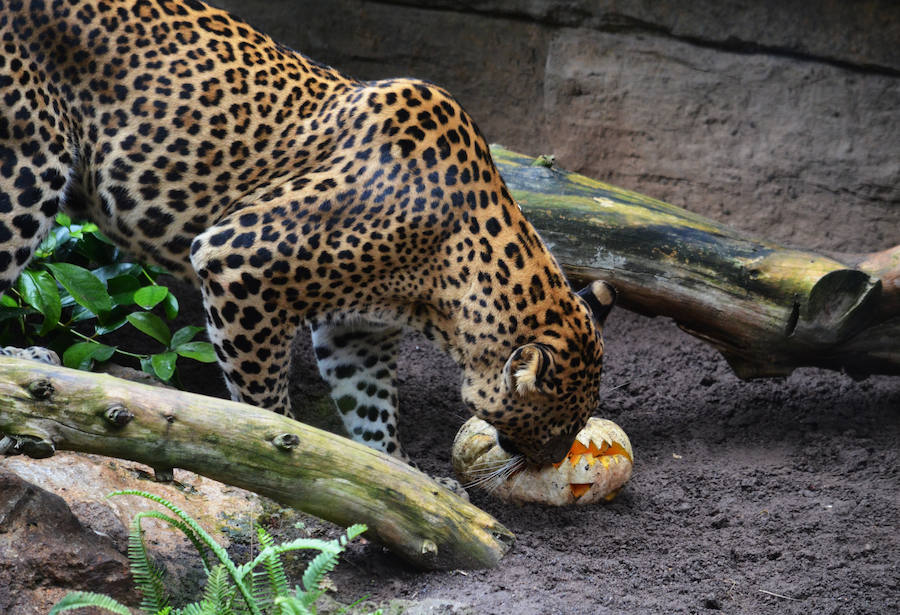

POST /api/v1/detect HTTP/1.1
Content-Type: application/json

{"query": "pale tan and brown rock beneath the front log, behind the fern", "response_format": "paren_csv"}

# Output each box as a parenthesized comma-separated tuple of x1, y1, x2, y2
(0, 451, 262, 615)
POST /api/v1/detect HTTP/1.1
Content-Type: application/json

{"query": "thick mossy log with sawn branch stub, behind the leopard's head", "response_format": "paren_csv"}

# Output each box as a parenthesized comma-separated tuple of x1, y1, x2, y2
(492, 146, 900, 378)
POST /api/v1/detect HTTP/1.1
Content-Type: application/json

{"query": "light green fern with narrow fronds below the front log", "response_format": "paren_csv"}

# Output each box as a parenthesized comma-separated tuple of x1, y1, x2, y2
(49, 490, 380, 615)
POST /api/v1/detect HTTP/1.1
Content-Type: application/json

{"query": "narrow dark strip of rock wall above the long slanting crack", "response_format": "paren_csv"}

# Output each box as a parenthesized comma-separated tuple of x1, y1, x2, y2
(393, 0, 900, 71)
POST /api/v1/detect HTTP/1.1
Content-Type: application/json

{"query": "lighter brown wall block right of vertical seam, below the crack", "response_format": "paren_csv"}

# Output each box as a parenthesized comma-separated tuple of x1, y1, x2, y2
(544, 30, 900, 251)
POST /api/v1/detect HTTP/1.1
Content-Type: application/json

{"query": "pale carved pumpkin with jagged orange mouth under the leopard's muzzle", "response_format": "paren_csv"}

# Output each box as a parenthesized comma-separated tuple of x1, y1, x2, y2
(453, 418, 633, 506)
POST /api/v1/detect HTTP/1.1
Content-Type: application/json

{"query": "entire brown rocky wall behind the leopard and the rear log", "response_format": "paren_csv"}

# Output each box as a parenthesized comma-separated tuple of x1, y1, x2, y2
(214, 0, 900, 252)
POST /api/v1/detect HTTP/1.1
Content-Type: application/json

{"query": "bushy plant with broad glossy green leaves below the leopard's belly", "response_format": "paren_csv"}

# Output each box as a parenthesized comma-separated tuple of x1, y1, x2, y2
(0, 214, 216, 382)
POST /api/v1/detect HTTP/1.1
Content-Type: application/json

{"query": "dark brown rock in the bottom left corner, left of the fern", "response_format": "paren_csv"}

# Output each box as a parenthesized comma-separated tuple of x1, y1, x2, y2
(0, 467, 138, 615)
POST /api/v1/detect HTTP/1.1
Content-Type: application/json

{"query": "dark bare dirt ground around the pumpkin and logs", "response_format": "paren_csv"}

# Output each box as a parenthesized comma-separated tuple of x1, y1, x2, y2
(214, 311, 900, 615)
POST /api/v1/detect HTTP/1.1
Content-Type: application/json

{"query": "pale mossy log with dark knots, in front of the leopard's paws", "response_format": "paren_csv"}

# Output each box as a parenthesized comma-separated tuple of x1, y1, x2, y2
(0, 357, 514, 569)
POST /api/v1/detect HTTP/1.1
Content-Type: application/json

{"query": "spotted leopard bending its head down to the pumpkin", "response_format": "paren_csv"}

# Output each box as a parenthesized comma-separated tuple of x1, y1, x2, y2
(0, 0, 615, 464)
